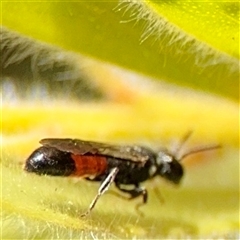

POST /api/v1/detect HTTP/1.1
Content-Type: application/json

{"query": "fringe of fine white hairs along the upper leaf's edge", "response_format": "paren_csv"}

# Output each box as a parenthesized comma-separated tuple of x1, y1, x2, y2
(114, 0, 239, 73)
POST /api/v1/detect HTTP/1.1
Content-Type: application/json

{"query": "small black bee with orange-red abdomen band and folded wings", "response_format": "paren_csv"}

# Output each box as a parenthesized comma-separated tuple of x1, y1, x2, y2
(24, 133, 220, 216)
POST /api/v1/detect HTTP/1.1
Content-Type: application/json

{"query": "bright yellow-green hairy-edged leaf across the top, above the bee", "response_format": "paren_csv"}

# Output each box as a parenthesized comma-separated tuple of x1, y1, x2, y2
(2, 1, 239, 100)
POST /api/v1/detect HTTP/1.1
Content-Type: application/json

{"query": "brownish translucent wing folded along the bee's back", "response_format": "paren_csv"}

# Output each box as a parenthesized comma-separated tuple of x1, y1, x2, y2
(40, 138, 154, 162)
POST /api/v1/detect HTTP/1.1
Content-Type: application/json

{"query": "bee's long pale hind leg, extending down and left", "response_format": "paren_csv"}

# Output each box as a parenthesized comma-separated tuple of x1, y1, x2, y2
(81, 167, 119, 217)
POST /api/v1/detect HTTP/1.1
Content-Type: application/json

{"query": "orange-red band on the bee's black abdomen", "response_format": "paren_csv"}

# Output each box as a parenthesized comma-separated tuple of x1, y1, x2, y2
(71, 154, 107, 177)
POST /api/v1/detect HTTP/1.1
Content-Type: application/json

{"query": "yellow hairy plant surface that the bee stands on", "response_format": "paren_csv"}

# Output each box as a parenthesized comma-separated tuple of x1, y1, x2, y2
(0, 101, 239, 239)
